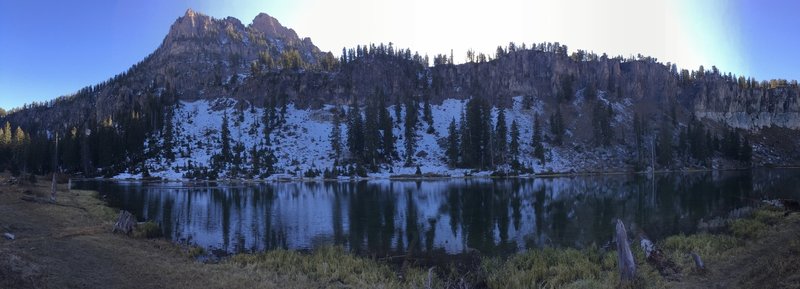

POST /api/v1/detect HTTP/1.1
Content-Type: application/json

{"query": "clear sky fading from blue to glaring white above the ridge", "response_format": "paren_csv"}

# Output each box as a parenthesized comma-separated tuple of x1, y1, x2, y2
(0, 0, 800, 110)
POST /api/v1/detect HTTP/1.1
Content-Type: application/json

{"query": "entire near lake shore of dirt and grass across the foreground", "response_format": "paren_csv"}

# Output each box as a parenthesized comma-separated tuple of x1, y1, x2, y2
(0, 174, 800, 288)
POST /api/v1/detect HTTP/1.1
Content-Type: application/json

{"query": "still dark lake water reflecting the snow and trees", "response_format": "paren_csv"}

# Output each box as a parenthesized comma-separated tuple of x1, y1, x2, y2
(73, 169, 800, 255)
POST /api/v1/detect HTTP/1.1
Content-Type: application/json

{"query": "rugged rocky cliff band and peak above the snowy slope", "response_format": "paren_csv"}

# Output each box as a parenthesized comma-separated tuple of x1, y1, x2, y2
(1, 10, 800, 169)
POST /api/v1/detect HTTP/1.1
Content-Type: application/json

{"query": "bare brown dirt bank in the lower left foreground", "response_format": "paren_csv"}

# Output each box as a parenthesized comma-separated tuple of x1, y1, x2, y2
(0, 177, 310, 288)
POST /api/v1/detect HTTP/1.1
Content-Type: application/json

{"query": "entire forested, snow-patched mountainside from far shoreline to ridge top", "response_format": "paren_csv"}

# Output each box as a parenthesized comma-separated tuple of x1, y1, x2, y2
(0, 10, 800, 179)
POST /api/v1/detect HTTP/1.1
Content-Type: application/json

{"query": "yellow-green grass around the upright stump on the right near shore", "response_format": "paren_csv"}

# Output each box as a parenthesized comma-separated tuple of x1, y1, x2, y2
(482, 207, 788, 288)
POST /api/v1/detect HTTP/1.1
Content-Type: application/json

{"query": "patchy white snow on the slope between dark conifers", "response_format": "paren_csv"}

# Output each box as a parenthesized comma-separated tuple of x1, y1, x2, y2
(116, 92, 630, 180)
